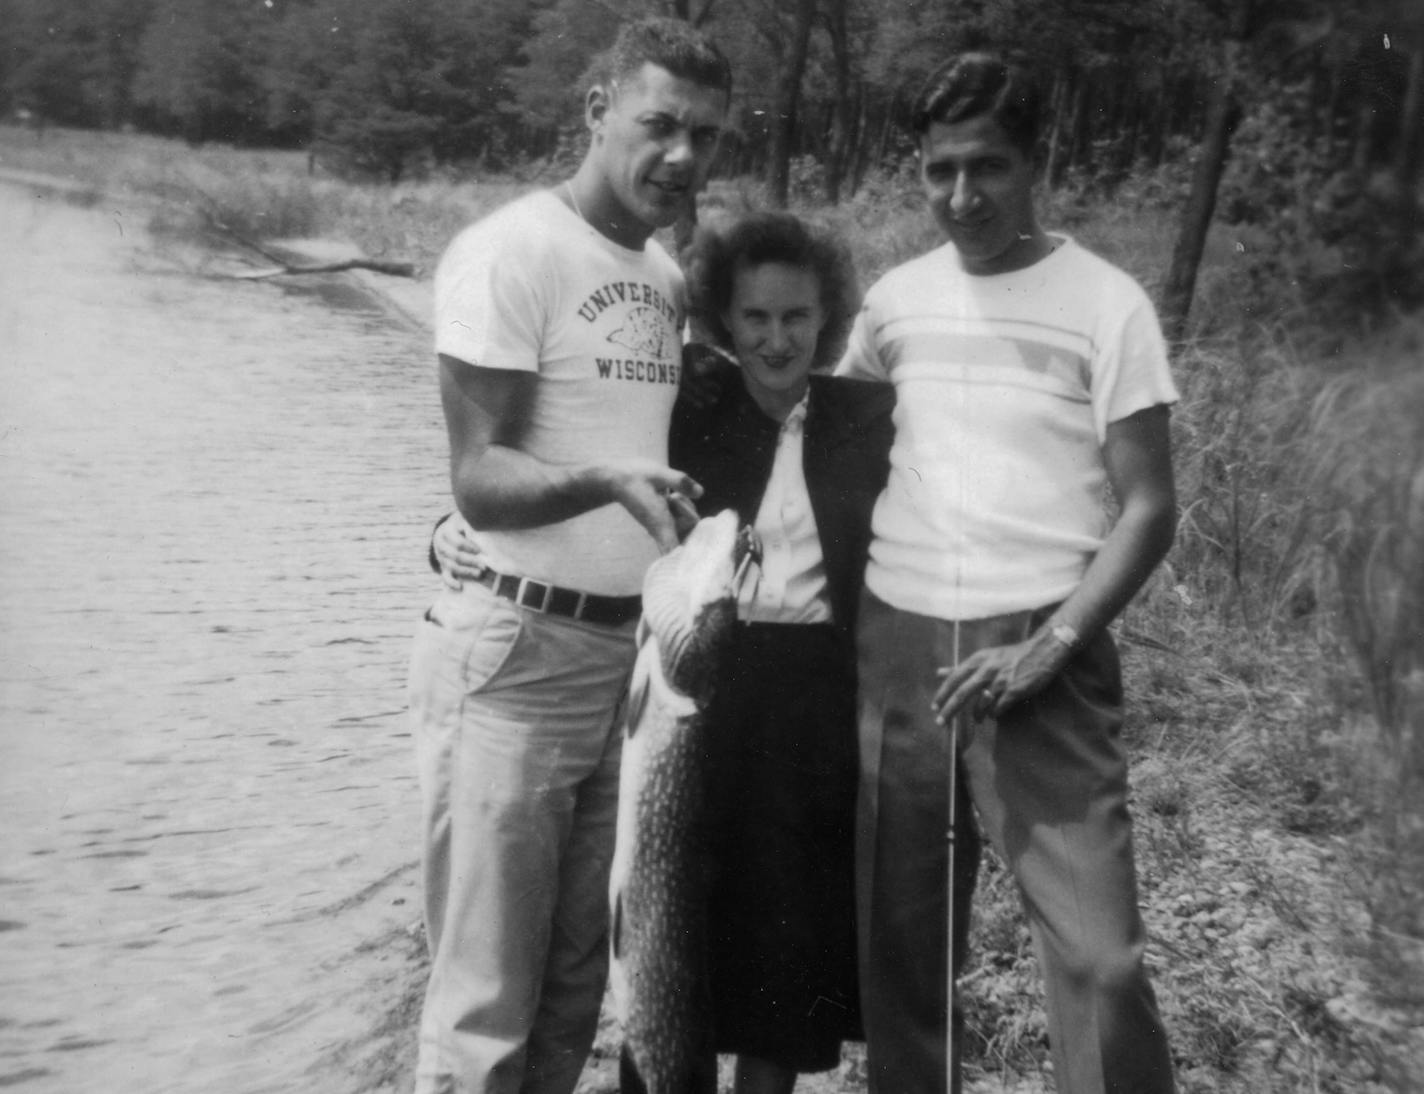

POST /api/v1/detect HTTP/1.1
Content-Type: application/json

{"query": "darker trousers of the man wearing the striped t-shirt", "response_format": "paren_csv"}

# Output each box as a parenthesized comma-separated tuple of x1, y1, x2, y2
(856, 593, 1173, 1094)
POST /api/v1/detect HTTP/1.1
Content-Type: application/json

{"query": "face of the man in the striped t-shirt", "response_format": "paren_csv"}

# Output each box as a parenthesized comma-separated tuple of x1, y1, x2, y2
(920, 114, 1042, 275)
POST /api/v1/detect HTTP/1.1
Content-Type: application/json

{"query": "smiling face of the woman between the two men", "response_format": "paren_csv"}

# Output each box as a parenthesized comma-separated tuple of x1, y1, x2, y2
(722, 262, 826, 410)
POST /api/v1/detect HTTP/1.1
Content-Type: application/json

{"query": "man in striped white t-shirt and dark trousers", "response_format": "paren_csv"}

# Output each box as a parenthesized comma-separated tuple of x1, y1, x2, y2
(837, 53, 1176, 1094)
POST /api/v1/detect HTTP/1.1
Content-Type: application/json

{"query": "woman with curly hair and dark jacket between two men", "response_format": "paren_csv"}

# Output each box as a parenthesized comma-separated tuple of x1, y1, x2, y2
(669, 212, 977, 1094)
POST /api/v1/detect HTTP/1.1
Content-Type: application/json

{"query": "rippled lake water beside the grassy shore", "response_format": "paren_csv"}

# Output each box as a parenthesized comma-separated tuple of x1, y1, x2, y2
(0, 185, 447, 1094)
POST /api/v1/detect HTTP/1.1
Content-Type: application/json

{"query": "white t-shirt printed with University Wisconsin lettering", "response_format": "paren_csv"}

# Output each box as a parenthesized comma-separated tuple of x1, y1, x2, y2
(434, 191, 685, 595)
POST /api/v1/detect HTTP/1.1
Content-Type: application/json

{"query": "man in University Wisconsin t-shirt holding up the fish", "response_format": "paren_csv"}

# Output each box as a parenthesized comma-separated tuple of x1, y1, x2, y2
(410, 20, 731, 1094)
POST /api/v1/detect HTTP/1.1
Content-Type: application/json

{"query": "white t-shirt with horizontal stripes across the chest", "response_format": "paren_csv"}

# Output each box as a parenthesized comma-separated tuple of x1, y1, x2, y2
(836, 236, 1178, 620)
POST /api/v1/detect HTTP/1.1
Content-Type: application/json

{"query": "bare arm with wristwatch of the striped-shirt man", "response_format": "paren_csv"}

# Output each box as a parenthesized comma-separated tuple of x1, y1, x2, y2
(934, 406, 1176, 721)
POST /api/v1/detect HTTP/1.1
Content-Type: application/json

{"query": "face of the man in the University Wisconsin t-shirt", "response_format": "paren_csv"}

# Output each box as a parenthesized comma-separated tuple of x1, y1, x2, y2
(588, 63, 726, 232)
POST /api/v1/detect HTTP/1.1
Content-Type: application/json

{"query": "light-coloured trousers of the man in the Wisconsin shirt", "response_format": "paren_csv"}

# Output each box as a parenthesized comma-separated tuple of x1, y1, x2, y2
(410, 583, 635, 1094)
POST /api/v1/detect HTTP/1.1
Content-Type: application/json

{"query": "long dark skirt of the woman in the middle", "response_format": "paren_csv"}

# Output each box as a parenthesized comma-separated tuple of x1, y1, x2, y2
(706, 624, 863, 1071)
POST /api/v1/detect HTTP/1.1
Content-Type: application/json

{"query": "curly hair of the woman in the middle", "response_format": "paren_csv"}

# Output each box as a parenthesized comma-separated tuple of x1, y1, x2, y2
(684, 212, 860, 369)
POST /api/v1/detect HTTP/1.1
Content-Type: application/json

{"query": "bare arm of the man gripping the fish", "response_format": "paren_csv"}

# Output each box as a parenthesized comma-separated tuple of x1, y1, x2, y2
(440, 355, 702, 551)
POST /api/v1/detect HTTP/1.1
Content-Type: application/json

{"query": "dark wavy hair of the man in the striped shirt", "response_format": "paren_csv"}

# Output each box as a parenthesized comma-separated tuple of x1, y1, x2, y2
(910, 50, 1044, 155)
